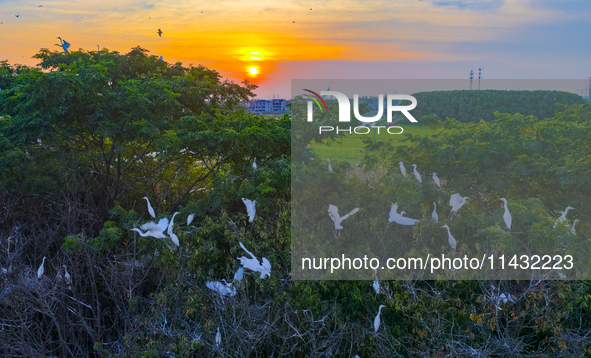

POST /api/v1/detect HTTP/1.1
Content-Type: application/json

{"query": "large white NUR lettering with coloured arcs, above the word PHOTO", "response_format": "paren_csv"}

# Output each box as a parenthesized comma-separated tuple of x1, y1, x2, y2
(304, 89, 418, 123)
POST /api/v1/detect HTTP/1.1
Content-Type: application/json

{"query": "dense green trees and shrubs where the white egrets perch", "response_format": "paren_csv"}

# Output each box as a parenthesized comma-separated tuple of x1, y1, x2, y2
(0, 48, 591, 358)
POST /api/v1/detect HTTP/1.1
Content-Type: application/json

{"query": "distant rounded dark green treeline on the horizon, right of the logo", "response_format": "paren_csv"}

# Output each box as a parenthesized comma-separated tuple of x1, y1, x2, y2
(412, 90, 584, 123)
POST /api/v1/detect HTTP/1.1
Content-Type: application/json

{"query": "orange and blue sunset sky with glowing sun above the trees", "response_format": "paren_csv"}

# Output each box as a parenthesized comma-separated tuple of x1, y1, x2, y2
(0, 0, 591, 98)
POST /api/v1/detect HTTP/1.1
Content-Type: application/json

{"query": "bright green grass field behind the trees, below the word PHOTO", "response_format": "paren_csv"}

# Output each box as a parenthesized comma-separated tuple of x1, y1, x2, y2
(310, 125, 434, 162)
